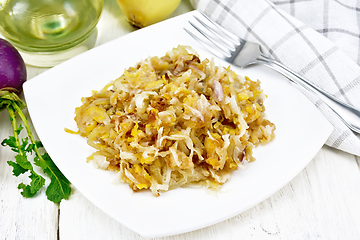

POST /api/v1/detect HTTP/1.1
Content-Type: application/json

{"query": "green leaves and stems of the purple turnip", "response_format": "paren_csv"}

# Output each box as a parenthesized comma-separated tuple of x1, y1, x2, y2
(0, 91, 71, 203)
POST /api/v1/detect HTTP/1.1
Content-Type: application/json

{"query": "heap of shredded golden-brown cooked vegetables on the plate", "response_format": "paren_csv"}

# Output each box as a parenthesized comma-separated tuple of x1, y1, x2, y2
(75, 46, 275, 196)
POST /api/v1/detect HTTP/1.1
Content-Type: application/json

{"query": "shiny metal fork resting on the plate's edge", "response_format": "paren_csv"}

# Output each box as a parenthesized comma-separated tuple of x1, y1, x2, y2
(184, 11, 360, 133)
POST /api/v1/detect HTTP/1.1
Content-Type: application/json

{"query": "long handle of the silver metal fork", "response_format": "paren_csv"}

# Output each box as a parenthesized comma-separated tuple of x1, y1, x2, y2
(257, 55, 360, 133)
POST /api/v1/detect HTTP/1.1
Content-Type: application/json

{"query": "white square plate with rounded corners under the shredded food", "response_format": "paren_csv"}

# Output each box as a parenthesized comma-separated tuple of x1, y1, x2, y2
(24, 12, 332, 237)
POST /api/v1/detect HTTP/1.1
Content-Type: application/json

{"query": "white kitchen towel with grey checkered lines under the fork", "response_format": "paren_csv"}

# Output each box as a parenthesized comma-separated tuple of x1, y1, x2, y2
(191, 0, 360, 156)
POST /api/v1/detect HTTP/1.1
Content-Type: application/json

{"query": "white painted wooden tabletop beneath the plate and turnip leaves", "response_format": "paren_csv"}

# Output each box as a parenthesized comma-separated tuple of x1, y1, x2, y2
(0, 0, 360, 240)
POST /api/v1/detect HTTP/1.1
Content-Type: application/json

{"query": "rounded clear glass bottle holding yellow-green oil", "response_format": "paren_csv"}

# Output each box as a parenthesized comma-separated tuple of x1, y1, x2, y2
(0, 0, 103, 66)
